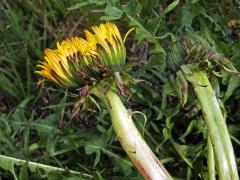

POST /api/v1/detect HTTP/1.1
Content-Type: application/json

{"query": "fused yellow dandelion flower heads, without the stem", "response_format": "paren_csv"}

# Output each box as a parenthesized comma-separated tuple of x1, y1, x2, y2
(36, 22, 132, 88)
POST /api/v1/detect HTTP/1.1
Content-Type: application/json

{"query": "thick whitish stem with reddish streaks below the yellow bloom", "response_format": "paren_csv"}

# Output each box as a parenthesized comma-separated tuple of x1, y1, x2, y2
(106, 90, 172, 180)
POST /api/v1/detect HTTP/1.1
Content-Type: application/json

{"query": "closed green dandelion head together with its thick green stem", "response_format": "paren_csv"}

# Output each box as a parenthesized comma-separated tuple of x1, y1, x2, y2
(167, 33, 239, 180)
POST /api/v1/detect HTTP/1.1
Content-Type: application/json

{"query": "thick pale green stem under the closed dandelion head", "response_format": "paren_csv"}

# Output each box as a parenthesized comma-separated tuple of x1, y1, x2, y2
(185, 71, 239, 180)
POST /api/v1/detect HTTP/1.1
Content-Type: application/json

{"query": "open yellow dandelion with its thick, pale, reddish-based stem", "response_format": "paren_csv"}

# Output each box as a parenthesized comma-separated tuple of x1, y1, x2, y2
(36, 22, 171, 179)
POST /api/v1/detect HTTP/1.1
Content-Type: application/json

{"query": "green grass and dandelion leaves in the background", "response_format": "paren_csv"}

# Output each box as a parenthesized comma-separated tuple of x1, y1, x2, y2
(0, 0, 240, 179)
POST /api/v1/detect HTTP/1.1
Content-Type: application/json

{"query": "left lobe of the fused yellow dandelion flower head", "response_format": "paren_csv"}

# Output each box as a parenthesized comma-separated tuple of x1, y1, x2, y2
(36, 37, 94, 87)
